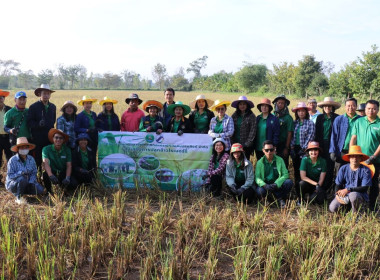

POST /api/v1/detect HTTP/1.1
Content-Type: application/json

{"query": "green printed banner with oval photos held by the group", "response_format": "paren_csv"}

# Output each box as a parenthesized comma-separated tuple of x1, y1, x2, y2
(98, 131, 212, 191)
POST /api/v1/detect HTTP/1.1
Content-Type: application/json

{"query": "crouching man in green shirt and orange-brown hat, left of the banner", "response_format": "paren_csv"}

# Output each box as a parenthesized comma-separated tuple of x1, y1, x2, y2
(42, 128, 78, 192)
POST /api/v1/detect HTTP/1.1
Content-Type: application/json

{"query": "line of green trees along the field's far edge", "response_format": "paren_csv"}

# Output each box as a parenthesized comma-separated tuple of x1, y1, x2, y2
(0, 45, 380, 99)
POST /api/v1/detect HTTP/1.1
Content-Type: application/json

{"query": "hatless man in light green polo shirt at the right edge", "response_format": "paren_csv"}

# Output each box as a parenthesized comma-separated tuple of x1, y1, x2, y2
(350, 100, 380, 211)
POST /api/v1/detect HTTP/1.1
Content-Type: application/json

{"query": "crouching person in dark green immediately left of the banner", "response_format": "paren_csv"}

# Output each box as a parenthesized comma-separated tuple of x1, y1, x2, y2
(72, 133, 96, 184)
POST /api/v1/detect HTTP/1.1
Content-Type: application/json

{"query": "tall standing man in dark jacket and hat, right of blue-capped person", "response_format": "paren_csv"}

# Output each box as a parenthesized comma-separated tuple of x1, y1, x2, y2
(28, 84, 56, 169)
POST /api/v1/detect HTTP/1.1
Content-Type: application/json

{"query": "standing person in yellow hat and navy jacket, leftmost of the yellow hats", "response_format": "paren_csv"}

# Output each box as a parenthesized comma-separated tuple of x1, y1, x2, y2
(74, 95, 98, 151)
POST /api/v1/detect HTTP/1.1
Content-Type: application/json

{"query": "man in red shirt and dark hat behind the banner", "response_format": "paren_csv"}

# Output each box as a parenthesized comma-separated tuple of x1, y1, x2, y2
(120, 93, 144, 132)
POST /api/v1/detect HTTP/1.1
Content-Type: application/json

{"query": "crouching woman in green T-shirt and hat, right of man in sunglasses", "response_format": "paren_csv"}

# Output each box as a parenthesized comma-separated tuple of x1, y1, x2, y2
(296, 141, 327, 204)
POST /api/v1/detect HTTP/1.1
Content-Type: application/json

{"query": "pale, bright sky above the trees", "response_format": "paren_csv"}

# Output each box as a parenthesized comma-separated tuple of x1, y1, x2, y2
(0, 0, 380, 79)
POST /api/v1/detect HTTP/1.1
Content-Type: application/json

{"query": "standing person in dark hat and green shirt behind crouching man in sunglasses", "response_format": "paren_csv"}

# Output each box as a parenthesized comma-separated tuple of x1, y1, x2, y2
(272, 94, 294, 168)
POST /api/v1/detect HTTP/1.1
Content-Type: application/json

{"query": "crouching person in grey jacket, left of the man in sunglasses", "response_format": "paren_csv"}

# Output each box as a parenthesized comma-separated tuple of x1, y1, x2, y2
(226, 143, 255, 203)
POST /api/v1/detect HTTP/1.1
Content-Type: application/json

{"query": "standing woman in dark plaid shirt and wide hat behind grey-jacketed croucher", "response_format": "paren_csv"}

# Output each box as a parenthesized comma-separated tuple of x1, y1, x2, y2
(231, 96, 256, 160)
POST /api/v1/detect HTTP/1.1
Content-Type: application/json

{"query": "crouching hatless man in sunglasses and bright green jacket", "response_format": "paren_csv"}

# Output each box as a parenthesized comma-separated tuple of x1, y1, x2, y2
(255, 140, 293, 208)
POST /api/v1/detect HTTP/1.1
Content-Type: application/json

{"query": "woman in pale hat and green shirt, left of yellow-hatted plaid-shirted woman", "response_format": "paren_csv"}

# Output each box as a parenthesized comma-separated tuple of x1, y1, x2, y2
(189, 94, 215, 134)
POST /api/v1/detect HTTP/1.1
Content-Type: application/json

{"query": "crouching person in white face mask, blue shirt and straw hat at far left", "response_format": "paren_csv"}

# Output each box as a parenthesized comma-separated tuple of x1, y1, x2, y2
(5, 137, 45, 204)
